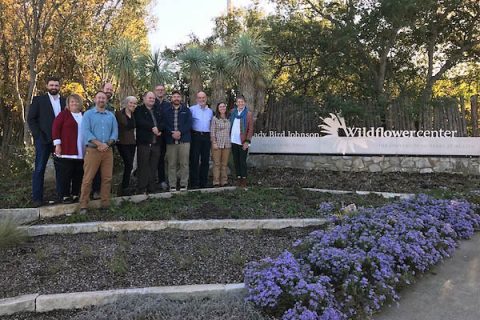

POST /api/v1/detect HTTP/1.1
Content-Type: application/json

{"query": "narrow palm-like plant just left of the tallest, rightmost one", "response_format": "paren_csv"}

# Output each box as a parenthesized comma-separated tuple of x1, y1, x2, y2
(208, 49, 231, 108)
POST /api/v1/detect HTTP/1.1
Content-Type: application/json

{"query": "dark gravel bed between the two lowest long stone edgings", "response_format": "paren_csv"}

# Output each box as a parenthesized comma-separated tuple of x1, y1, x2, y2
(0, 228, 318, 298)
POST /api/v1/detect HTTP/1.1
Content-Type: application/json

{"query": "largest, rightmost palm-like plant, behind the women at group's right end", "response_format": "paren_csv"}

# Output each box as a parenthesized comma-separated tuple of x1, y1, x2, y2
(232, 34, 265, 111)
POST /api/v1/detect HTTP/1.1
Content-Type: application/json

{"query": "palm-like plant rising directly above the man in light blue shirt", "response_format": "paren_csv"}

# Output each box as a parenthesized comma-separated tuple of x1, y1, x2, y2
(178, 46, 207, 103)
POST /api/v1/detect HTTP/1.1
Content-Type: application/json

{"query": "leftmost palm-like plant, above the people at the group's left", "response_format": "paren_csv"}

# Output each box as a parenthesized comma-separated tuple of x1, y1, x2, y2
(108, 39, 137, 101)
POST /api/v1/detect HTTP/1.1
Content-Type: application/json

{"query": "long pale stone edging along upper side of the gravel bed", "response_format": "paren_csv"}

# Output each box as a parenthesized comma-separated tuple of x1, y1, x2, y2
(20, 218, 327, 237)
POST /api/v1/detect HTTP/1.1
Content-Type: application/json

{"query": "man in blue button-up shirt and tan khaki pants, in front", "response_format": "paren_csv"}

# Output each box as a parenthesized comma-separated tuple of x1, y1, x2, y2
(80, 91, 118, 214)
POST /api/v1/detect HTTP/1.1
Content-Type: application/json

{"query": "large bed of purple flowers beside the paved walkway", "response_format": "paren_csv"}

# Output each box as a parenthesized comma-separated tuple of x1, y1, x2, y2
(245, 195, 480, 320)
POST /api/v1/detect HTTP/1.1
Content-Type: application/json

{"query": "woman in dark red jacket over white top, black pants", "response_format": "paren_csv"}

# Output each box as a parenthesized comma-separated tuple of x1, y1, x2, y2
(52, 94, 85, 203)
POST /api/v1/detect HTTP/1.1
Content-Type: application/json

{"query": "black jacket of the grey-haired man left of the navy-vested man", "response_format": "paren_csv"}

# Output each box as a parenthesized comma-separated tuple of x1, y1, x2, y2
(133, 104, 164, 144)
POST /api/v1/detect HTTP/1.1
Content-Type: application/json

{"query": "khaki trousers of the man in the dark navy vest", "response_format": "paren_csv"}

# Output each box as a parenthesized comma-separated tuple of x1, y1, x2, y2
(166, 143, 190, 188)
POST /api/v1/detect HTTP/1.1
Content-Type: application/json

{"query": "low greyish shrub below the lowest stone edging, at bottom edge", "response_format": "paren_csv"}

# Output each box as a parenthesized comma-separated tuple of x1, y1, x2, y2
(73, 295, 267, 320)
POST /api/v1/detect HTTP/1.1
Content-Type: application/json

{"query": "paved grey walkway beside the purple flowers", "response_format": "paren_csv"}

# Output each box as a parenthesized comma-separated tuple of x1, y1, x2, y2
(375, 233, 480, 320)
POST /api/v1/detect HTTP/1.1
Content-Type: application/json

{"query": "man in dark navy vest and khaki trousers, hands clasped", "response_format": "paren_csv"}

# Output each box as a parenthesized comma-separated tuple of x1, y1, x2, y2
(163, 91, 192, 192)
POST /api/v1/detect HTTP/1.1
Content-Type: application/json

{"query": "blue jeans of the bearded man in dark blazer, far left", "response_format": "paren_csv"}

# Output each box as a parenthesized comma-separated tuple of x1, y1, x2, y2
(32, 139, 62, 202)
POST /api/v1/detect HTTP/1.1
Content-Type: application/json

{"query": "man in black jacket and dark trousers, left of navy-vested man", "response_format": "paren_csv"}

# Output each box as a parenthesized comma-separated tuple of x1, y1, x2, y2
(134, 92, 163, 193)
